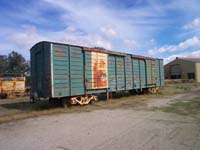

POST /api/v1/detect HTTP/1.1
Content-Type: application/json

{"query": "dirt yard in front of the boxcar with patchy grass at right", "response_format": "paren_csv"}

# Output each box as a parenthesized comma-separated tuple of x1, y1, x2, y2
(0, 84, 200, 150)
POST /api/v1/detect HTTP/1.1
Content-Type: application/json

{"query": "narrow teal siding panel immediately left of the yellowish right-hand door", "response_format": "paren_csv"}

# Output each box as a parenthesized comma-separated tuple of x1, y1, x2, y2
(139, 60, 146, 88)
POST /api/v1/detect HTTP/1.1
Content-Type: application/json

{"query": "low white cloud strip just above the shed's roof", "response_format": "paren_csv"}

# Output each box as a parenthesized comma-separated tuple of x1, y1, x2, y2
(164, 50, 200, 64)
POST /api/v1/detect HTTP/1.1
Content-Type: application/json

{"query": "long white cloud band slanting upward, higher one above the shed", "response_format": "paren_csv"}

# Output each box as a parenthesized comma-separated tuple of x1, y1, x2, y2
(148, 36, 200, 55)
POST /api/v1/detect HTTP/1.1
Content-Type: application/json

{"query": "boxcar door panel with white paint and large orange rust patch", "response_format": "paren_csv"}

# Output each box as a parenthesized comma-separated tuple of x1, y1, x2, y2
(84, 51, 109, 94)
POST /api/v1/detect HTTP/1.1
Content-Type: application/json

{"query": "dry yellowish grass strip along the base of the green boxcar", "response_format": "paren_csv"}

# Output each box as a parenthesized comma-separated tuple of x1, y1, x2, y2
(0, 83, 200, 123)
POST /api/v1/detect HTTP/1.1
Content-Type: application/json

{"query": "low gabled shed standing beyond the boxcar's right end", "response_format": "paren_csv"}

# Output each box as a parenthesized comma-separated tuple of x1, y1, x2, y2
(164, 57, 200, 82)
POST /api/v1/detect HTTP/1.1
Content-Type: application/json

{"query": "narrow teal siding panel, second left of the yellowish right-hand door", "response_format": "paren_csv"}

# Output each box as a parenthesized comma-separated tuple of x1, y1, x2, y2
(132, 59, 140, 89)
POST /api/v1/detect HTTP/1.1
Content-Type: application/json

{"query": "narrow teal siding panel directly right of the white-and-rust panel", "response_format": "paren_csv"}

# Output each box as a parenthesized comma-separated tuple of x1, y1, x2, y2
(108, 55, 117, 91)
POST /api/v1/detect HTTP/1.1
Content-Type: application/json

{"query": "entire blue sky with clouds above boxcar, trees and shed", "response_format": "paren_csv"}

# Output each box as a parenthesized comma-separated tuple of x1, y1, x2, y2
(0, 0, 200, 63)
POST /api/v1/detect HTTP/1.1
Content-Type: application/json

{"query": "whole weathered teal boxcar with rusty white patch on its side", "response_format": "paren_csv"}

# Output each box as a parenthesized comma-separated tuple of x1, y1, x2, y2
(30, 41, 164, 105)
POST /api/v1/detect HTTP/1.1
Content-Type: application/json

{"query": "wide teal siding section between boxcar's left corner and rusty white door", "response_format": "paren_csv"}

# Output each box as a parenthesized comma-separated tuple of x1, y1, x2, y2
(52, 44, 84, 97)
